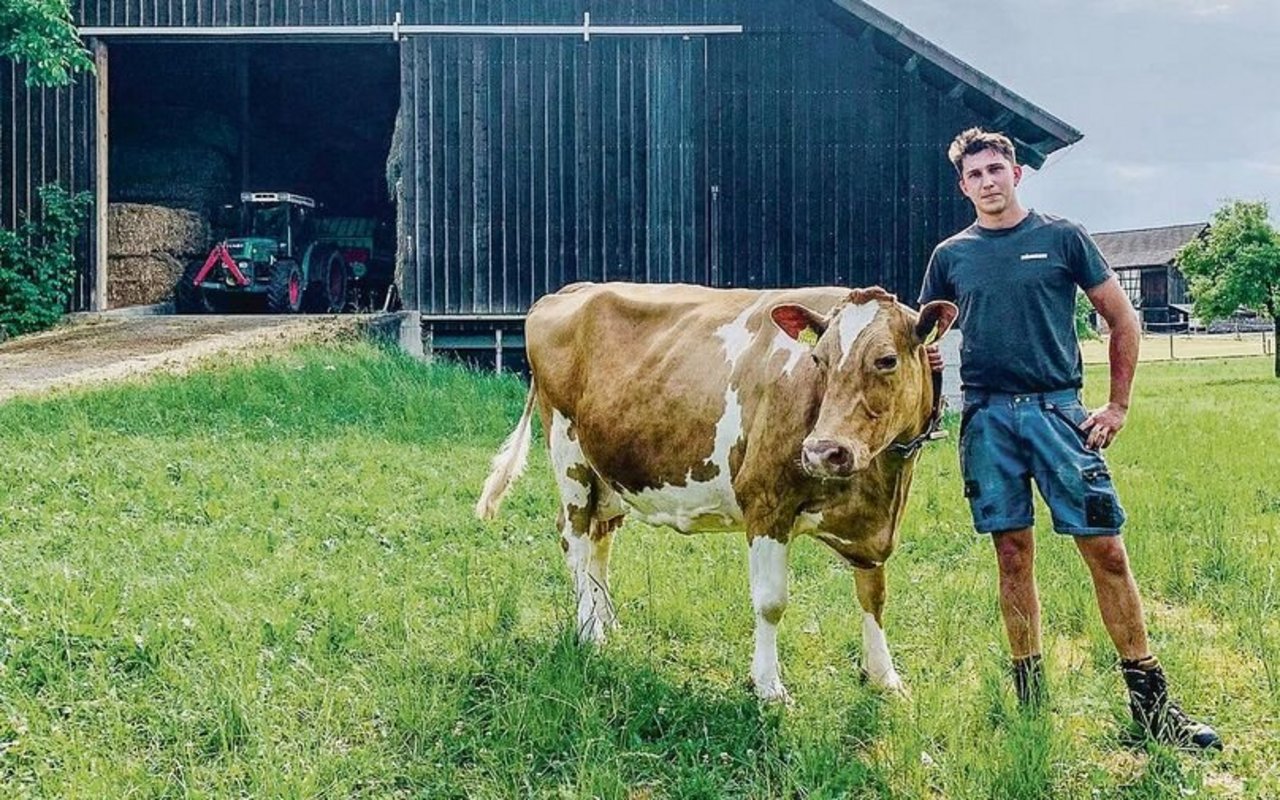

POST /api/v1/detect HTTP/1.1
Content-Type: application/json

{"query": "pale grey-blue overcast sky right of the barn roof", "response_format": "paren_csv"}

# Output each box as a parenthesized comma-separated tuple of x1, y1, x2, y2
(870, 0, 1280, 232)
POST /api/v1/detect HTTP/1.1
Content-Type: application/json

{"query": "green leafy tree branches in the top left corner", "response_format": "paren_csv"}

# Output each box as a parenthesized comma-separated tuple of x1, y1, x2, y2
(0, 0, 93, 86)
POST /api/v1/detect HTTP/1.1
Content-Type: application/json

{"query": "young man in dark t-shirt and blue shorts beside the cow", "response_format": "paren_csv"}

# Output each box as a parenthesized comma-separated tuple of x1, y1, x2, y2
(920, 128, 1222, 748)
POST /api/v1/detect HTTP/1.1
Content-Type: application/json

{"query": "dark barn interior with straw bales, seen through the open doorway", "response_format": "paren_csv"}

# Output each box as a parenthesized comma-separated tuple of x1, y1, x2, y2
(108, 40, 399, 307)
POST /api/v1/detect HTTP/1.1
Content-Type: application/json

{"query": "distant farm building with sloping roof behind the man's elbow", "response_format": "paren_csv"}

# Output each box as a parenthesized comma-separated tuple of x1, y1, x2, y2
(1093, 223, 1208, 329)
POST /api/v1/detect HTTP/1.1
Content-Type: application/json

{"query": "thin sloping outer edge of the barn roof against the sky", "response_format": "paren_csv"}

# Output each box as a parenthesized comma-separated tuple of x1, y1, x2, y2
(831, 0, 1084, 168)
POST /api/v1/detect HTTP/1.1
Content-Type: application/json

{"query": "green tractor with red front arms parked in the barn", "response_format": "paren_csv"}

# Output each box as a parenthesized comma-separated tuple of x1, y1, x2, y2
(174, 192, 355, 314)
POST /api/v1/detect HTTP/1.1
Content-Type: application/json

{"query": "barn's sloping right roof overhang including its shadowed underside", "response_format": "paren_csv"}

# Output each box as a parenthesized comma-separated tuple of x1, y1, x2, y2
(832, 0, 1084, 169)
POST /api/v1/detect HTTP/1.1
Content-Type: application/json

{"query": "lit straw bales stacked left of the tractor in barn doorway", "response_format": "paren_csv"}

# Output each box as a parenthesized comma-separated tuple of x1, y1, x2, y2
(106, 202, 209, 308)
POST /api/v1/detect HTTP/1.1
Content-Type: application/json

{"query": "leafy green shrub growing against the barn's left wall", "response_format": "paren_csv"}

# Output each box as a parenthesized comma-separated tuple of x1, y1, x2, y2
(0, 186, 91, 340)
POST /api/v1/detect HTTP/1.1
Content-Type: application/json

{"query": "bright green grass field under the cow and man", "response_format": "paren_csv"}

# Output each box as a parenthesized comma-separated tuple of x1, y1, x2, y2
(0, 346, 1280, 800)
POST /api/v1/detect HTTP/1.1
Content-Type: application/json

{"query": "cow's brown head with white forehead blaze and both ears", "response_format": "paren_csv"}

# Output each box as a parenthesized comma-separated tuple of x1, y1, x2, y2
(772, 287, 959, 479)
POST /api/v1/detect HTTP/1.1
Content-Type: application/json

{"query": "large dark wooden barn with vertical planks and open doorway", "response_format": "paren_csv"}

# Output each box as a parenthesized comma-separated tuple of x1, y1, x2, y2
(0, 0, 1082, 347)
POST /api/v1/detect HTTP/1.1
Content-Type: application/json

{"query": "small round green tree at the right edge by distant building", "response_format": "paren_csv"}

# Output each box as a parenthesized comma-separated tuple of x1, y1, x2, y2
(1178, 200, 1280, 378)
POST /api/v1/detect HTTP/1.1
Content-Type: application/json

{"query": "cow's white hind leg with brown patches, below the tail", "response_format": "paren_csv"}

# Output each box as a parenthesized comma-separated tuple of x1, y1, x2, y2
(548, 411, 616, 644)
